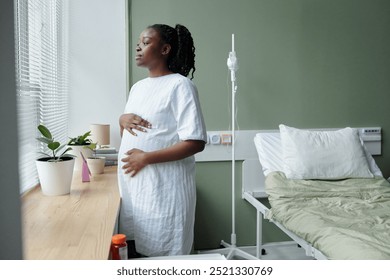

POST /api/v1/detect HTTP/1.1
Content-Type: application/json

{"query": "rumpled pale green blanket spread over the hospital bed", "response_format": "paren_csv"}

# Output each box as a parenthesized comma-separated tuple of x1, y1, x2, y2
(266, 172, 390, 260)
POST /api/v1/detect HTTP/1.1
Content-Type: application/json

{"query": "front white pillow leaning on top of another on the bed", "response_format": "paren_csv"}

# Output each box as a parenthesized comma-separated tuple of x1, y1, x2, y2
(279, 124, 373, 180)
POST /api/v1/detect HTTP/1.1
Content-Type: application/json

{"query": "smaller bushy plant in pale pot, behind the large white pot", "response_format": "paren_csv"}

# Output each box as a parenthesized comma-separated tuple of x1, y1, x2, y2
(68, 131, 96, 170)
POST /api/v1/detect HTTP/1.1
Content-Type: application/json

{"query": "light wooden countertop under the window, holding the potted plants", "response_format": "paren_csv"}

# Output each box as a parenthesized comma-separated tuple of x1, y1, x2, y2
(22, 166, 120, 260)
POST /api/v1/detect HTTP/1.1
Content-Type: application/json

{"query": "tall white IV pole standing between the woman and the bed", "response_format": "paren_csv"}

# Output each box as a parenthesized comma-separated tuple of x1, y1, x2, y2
(203, 34, 258, 260)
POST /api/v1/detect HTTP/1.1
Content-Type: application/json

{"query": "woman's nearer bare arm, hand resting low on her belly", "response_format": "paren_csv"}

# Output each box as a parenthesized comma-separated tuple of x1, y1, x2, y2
(122, 140, 205, 177)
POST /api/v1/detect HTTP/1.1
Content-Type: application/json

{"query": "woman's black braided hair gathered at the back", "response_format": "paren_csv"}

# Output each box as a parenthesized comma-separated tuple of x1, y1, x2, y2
(148, 24, 196, 80)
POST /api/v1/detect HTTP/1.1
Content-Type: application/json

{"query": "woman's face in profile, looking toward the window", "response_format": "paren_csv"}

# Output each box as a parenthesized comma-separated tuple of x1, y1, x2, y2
(135, 28, 170, 69)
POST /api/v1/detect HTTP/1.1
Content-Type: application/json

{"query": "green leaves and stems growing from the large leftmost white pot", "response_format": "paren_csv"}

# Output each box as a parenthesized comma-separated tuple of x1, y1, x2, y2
(37, 124, 74, 162)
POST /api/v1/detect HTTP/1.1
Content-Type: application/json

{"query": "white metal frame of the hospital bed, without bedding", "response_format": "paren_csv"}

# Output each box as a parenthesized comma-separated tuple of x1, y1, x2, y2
(242, 130, 381, 260)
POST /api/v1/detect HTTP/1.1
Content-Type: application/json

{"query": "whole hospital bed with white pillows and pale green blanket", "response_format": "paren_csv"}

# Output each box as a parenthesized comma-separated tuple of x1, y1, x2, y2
(242, 126, 390, 259)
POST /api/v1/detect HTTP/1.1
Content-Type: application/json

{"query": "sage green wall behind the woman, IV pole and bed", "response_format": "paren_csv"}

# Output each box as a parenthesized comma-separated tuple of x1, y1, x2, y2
(129, 0, 390, 249)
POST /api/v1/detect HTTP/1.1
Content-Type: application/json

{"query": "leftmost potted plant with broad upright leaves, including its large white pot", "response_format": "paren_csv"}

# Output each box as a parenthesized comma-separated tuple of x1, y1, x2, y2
(36, 125, 75, 196)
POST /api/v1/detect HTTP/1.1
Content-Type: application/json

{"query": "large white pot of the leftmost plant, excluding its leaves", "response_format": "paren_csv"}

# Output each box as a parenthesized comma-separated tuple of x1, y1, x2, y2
(35, 157, 75, 196)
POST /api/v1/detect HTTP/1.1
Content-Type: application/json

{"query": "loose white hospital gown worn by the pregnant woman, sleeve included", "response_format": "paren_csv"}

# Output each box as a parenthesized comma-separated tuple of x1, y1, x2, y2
(118, 74, 207, 256)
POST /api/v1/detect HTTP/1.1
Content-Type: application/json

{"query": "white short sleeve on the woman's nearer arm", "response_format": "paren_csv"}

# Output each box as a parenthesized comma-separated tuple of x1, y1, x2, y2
(171, 77, 207, 142)
